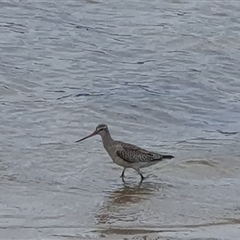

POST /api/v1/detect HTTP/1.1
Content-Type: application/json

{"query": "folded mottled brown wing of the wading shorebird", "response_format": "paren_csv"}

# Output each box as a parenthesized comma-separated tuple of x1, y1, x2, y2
(116, 144, 163, 163)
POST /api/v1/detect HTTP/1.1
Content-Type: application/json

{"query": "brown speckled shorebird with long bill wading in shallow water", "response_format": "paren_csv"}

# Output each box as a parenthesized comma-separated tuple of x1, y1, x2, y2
(76, 124, 174, 182)
